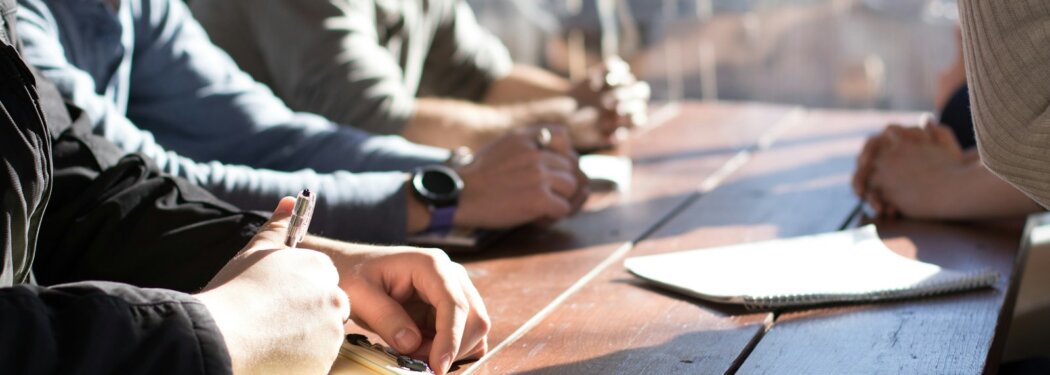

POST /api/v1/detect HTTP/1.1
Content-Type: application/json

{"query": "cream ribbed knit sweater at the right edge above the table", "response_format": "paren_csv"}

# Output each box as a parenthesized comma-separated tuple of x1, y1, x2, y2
(960, 0, 1050, 207)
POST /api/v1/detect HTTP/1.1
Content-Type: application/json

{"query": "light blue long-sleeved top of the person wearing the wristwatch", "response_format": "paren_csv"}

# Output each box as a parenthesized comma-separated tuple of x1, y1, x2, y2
(18, 0, 448, 243)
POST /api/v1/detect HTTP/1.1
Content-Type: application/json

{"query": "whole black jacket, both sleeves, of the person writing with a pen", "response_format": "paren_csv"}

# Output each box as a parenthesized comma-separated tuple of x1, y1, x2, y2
(0, 0, 256, 374)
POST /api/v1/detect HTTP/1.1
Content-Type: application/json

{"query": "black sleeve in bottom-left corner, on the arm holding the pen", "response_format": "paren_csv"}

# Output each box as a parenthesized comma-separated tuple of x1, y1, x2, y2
(0, 283, 231, 374)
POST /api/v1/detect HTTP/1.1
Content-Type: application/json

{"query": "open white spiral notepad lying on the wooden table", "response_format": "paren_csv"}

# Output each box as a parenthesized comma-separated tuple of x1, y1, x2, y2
(625, 225, 999, 310)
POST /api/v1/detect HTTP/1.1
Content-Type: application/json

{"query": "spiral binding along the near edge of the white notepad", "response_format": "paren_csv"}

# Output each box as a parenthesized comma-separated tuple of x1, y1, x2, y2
(743, 271, 999, 311)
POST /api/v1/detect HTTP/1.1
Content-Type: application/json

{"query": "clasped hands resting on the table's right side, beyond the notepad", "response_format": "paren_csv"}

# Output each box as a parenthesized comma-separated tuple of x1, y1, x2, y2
(853, 123, 975, 218)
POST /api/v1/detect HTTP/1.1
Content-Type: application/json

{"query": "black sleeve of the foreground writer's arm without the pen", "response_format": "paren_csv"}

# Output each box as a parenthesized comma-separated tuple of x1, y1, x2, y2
(34, 64, 268, 292)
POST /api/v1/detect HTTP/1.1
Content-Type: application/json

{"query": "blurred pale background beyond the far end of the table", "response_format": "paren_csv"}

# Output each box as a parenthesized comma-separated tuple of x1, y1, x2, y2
(468, 0, 958, 110)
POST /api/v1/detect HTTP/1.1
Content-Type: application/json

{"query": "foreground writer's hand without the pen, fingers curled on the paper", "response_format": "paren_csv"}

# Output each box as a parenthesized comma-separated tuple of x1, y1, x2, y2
(305, 236, 490, 374)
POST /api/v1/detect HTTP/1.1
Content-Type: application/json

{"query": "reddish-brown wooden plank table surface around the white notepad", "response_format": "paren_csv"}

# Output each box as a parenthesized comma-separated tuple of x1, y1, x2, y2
(457, 103, 1023, 374)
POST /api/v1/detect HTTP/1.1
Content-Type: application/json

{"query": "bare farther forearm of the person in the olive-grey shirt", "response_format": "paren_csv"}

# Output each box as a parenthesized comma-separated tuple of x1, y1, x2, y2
(485, 65, 572, 105)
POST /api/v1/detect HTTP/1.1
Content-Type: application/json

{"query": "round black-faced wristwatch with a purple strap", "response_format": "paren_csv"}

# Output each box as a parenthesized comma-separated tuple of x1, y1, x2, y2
(412, 165, 463, 232)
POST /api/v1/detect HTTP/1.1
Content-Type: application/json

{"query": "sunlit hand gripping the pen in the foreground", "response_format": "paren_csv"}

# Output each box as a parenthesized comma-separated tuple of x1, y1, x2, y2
(195, 197, 350, 374)
